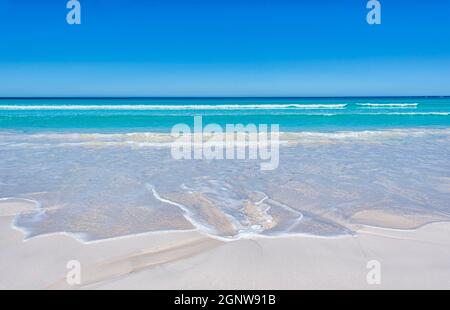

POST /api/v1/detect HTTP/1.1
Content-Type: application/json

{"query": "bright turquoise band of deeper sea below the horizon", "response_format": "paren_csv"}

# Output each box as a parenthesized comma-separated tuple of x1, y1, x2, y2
(0, 97, 450, 132)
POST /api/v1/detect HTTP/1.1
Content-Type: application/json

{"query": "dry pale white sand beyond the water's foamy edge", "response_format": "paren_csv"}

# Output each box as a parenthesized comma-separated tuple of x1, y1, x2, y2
(0, 201, 450, 289)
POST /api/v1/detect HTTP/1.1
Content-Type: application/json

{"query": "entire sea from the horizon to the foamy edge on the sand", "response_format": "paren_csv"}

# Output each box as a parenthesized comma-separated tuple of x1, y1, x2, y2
(0, 97, 450, 242)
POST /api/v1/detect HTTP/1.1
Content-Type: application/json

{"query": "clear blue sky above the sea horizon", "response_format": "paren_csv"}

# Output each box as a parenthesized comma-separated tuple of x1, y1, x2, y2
(0, 0, 450, 96)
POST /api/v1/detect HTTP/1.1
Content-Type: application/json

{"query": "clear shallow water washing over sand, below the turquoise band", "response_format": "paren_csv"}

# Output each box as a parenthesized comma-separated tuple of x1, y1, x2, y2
(0, 128, 450, 241)
